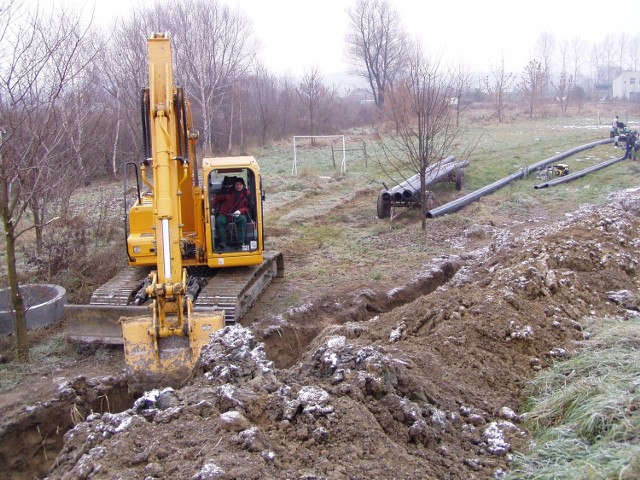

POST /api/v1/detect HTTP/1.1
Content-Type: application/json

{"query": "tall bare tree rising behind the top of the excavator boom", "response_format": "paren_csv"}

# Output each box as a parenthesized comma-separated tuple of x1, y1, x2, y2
(109, 0, 258, 154)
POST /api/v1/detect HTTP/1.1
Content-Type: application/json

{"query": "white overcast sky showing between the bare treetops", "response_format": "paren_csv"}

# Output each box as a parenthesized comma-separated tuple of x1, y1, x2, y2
(69, 0, 640, 76)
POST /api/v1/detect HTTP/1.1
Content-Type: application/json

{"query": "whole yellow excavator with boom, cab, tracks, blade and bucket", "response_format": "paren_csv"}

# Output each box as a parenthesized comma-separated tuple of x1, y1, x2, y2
(65, 33, 284, 391)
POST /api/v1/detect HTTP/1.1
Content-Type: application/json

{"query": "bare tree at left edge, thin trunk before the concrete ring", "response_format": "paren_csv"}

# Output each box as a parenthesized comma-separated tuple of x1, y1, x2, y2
(0, 0, 94, 361)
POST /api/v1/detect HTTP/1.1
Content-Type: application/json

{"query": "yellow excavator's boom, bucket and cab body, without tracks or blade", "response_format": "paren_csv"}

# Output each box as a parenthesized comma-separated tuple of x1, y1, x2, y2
(121, 35, 263, 390)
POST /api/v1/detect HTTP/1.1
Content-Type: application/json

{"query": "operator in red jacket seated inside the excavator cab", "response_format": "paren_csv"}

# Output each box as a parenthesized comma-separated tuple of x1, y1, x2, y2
(213, 177, 250, 250)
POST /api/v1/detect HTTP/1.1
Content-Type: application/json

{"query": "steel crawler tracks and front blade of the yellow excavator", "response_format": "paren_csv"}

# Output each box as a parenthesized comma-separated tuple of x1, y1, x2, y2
(65, 252, 284, 344)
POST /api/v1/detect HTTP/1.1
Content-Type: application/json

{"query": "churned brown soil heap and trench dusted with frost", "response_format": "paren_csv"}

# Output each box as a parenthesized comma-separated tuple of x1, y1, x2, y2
(0, 182, 640, 479)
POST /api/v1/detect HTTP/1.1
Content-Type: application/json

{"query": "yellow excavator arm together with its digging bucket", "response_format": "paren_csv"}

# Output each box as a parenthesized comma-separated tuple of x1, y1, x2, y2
(121, 34, 225, 390)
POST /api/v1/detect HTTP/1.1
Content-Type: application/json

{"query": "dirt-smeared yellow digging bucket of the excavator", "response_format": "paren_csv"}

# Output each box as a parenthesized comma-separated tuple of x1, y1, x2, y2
(121, 310, 225, 394)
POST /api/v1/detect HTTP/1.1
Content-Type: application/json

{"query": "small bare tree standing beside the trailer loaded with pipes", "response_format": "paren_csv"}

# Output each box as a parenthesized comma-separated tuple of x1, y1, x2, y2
(380, 45, 461, 230)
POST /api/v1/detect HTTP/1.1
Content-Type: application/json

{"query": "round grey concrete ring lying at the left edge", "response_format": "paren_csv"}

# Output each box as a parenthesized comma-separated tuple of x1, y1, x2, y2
(0, 284, 67, 335)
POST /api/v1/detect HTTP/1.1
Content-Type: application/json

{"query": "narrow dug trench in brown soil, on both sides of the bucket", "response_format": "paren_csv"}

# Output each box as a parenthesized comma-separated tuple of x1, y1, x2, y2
(0, 253, 460, 479)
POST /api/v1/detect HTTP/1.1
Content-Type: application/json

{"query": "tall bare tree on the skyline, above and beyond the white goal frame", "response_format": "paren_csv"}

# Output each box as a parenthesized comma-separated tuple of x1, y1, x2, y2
(347, 0, 407, 107)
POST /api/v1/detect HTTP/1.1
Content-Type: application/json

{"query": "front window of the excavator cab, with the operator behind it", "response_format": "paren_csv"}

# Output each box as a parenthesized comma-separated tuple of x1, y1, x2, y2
(208, 169, 258, 253)
